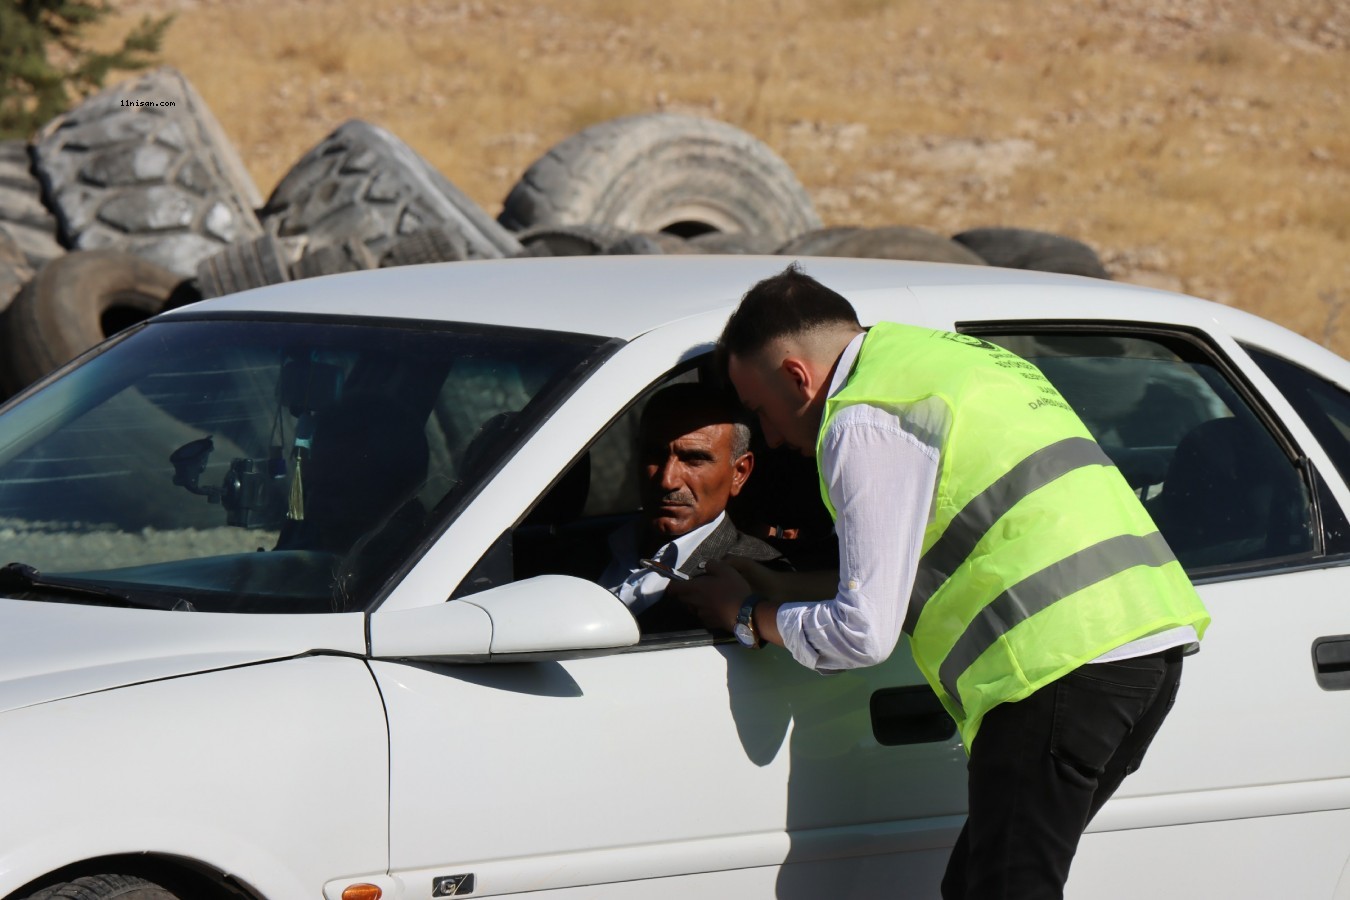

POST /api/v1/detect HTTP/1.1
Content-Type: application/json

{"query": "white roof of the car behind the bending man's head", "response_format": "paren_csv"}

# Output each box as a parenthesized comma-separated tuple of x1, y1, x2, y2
(166, 255, 1343, 362)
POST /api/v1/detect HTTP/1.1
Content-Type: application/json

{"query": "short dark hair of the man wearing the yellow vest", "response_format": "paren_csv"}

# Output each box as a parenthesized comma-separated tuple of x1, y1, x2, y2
(717, 262, 863, 372)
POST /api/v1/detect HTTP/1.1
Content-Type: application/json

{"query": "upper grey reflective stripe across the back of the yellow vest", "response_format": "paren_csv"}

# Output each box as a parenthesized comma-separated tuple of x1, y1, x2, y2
(903, 437, 1115, 636)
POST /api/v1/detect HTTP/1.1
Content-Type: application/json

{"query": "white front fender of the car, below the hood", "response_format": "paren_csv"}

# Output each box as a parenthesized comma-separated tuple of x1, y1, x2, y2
(0, 656, 389, 900)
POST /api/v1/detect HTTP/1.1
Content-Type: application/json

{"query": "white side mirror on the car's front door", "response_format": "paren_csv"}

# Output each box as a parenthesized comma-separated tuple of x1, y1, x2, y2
(370, 575, 640, 663)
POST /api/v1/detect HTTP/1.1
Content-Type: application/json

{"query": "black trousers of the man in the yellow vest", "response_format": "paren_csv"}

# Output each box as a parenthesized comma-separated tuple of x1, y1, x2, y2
(942, 648, 1181, 900)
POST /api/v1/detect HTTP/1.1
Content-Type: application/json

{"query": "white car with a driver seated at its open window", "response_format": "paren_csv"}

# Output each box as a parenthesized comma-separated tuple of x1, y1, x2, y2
(0, 256, 1350, 900)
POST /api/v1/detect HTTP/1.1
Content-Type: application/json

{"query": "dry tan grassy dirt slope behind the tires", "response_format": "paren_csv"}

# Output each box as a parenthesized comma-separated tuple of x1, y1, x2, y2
(89, 0, 1350, 355)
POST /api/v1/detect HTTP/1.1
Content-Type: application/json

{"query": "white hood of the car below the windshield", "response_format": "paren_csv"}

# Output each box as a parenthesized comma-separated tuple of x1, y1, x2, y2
(0, 598, 366, 712)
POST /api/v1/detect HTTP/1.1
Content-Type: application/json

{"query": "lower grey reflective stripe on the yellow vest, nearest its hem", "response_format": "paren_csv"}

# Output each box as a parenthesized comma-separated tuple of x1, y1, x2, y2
(938, 532, 1176, 708)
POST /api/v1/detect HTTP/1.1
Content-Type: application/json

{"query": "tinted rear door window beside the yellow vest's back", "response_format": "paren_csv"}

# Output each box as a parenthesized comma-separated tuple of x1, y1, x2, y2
(979, 331, 1319, 575)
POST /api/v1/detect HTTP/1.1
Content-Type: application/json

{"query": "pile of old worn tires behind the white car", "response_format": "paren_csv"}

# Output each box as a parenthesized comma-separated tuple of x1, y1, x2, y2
(0, 67, 1107, 397)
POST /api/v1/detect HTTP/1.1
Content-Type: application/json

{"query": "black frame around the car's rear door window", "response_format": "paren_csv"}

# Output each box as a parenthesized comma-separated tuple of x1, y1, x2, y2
(954, 318, 1350, 584)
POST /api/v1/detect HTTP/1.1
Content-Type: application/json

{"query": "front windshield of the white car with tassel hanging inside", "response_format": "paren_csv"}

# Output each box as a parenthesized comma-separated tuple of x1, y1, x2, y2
(0, 318, 608, 613)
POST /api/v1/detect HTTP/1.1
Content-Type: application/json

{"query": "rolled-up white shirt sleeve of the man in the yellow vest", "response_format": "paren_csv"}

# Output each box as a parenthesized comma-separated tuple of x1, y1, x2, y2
(778, 403, 938, 673)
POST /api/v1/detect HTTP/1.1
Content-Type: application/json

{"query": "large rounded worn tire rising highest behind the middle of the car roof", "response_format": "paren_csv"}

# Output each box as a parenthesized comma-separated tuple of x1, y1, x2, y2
(498, 113, 821, 242)
